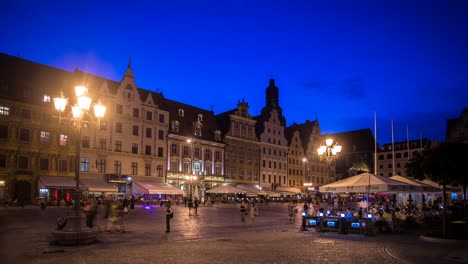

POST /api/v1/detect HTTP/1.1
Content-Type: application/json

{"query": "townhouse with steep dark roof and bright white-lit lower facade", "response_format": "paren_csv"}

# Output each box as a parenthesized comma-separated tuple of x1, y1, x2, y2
(165, 99, 225, 199)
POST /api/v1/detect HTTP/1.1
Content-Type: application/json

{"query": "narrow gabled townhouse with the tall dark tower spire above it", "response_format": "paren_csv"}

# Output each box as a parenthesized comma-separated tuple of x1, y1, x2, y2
(255, 79, 288, 189)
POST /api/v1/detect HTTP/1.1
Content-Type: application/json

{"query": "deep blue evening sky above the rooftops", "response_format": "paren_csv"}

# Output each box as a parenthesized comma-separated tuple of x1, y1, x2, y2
(0, 0, 468, 143)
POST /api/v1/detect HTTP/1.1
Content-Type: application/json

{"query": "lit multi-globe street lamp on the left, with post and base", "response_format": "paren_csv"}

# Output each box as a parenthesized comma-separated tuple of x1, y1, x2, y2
(52, 86, 106, 245)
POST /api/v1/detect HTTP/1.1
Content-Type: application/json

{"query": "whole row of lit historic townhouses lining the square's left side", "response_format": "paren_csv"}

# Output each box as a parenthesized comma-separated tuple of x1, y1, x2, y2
(0, 54, 335, 202)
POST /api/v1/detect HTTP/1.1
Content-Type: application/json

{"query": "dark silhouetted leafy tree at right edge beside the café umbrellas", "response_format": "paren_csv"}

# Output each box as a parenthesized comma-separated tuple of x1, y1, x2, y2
(405, 143, 468, 236)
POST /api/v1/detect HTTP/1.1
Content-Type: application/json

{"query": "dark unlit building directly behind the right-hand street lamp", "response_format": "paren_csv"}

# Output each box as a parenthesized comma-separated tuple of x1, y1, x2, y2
(330, 128, 375, 180)
